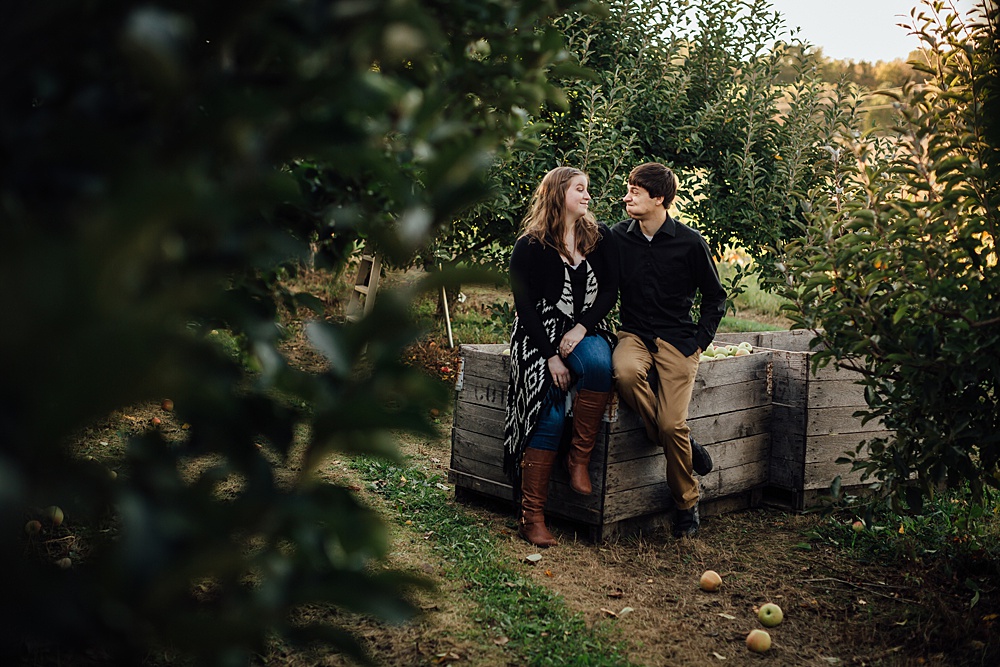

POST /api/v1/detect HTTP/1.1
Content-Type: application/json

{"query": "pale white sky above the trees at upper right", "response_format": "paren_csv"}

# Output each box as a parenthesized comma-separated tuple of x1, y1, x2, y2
(770, 0, 983, 62)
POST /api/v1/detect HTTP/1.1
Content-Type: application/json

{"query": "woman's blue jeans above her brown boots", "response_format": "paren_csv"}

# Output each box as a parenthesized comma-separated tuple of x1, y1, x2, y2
(526, 335, 612, 451)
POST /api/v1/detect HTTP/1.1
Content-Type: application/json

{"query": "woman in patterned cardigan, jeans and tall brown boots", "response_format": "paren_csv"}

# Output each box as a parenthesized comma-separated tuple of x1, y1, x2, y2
(504, 167, 618, 547)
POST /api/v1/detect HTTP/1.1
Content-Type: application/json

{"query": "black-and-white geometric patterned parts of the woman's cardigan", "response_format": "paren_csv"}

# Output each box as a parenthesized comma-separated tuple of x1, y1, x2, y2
(503, 260, 618, 492)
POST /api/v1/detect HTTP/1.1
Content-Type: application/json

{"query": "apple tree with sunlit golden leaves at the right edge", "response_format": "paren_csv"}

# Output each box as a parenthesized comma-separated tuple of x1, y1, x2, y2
(760, 2, 1000, 509)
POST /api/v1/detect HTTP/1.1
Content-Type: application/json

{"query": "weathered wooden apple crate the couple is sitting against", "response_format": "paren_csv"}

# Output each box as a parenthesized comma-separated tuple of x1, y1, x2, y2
(449, 345, 771, 540)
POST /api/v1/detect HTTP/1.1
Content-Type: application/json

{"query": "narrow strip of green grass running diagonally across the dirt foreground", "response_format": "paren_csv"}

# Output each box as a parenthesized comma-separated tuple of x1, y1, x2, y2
(351, 458, 630, 667)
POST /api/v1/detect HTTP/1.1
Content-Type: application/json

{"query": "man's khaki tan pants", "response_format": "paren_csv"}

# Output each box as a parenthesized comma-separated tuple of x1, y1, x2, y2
(612, 331, 698, 510)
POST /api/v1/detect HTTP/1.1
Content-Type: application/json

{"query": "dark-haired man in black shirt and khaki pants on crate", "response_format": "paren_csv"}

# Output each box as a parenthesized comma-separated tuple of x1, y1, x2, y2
(612, 162, 726, 538)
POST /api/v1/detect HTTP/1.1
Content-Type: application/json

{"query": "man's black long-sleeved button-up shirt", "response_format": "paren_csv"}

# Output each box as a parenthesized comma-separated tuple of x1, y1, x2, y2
(611, 215, 726, 356)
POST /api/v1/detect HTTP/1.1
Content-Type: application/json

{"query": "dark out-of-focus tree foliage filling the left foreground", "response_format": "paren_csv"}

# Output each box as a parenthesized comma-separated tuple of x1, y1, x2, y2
(0, 0, 584, 665)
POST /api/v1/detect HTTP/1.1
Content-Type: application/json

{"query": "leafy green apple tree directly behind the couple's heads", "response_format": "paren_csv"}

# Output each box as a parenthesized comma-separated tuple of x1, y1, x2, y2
(428, 0, 861, 306)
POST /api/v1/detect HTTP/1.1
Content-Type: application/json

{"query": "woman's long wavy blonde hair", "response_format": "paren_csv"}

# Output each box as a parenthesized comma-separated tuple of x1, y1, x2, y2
(521, 167, 601, 256)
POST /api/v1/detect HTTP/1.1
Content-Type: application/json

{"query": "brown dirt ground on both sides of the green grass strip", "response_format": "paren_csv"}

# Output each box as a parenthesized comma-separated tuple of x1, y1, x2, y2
(278, 421, 1000, 667)
